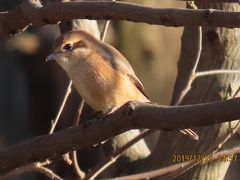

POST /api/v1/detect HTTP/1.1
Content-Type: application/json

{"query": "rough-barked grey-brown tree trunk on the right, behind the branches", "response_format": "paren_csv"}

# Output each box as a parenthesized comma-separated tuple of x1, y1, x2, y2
(145, 3, 240, 179)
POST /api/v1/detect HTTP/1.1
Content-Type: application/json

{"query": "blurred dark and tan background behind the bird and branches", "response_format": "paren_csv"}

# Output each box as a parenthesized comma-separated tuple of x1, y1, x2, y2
(0, 0, 237, 179)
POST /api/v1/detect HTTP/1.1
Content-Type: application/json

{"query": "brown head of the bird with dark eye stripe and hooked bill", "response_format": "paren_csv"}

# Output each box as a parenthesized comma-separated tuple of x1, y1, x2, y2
(46, 31, 99, 68)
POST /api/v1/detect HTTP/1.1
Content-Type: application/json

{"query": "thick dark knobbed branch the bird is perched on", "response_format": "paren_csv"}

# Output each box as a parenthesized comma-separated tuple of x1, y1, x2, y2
(0, 98, 240, 173)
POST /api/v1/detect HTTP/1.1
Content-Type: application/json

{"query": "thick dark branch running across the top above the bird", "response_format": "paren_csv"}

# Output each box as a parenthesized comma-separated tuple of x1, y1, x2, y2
(0, 0, 240, 35)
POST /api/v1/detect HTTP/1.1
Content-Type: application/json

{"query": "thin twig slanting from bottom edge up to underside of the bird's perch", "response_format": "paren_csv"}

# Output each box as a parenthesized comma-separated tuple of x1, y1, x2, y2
(85, 129, 154, 180)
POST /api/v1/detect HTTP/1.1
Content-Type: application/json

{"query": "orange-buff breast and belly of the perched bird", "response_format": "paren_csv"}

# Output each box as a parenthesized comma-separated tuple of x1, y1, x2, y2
(67, 57, 147, 112)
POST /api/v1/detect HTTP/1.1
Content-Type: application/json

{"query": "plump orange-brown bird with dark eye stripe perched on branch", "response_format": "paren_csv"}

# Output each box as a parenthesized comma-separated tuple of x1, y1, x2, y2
(46, 31, 198, 160)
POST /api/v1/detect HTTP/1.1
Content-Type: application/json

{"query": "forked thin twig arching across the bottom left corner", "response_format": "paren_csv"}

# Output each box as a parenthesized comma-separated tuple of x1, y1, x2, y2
(0, 161, 63, 180)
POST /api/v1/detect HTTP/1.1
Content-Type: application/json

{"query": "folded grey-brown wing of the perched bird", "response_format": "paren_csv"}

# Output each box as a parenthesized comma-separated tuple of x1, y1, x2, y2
(100, 43, 149, 99)
